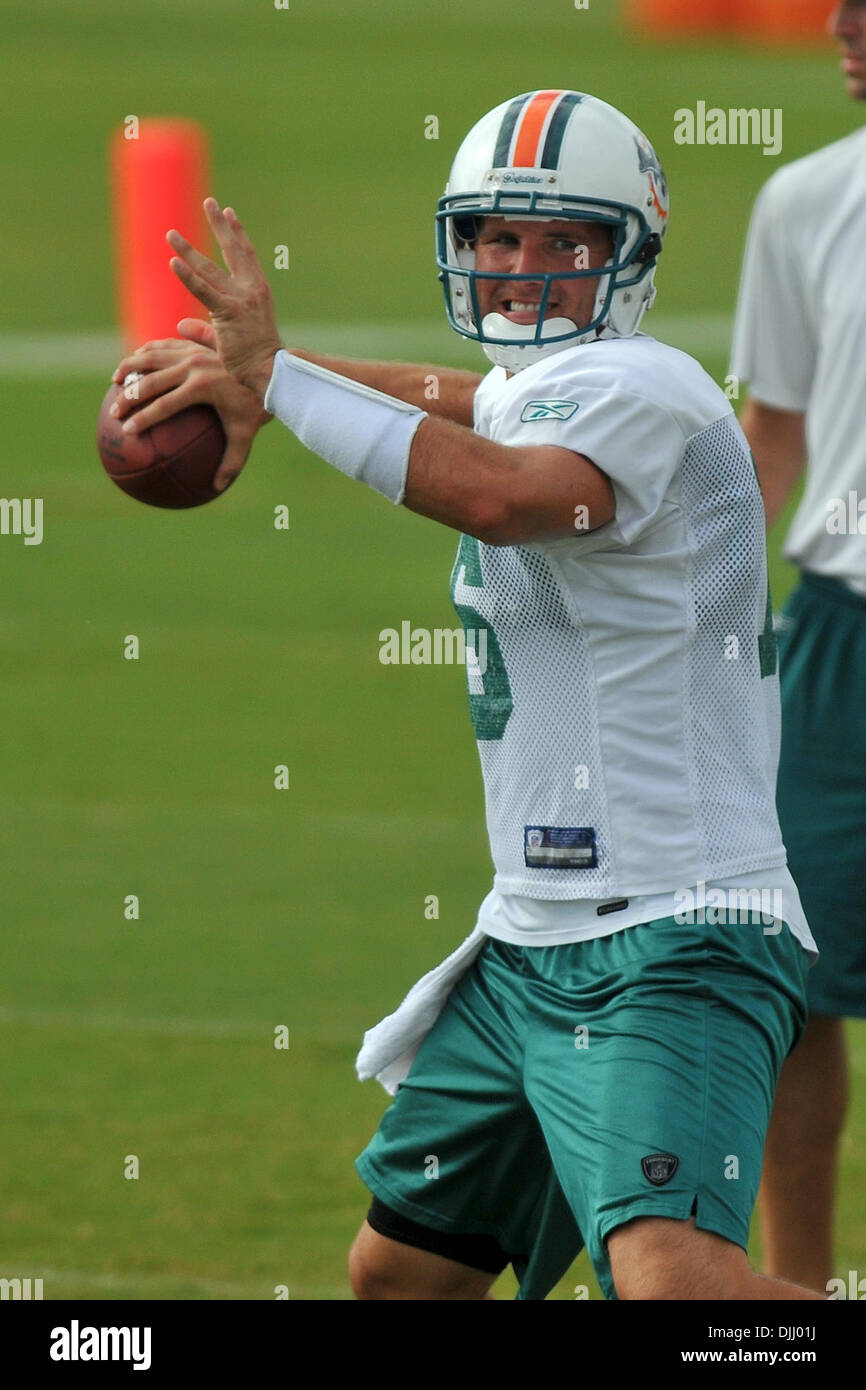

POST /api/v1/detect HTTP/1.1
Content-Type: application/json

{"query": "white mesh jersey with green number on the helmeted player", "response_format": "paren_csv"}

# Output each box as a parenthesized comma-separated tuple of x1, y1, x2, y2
(452, 335, 785, 899)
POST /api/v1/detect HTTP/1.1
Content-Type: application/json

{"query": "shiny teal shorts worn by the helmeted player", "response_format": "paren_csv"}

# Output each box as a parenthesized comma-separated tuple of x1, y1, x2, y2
(357, 912, 809, 1300)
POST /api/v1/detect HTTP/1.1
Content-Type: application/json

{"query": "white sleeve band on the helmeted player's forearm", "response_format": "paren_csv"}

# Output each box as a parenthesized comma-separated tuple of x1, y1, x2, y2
(264, 349, 427, 502)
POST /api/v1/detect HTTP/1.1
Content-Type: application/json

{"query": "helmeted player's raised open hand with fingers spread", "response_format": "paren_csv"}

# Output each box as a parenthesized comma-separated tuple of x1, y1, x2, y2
(165, 197, 282, 400)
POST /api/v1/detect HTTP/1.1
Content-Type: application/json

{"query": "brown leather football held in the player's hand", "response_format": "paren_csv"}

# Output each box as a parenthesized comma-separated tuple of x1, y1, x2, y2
(96, 377, 228, 507)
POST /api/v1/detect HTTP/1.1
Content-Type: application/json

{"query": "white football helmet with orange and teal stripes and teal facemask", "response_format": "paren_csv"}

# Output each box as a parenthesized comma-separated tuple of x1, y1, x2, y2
(436, 90, 669, 373)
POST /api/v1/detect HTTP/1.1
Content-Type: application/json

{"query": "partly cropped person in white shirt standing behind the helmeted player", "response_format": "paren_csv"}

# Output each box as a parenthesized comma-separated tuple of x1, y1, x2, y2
(731, 0, 866, 1289)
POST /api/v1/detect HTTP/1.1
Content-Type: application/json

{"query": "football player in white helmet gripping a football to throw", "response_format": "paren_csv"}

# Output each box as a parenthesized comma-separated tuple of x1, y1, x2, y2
(111, 90, 820, 1300)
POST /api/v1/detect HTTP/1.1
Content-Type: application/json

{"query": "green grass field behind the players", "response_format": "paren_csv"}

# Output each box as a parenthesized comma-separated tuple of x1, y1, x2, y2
(0, 0, 866, 1300)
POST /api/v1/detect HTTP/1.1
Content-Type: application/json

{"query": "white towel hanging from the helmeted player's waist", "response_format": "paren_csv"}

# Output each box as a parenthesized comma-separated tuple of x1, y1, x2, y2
(354, 927, 488, 1095)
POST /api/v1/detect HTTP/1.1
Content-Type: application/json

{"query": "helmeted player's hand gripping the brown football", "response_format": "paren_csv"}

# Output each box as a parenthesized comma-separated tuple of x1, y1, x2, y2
(111, 326, 271, 492)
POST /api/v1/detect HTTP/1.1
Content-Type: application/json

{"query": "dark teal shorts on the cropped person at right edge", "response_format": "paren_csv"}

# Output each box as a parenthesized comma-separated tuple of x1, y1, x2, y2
(777, 574, 866, 1017)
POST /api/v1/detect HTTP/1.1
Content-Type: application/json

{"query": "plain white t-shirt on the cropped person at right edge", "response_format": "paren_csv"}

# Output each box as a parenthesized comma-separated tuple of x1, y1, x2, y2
(730, 129, 866, 594)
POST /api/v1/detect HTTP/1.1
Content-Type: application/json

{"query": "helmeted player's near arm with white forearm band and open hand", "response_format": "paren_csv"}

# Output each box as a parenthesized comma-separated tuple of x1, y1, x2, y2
(148, 199, 616, 545)
